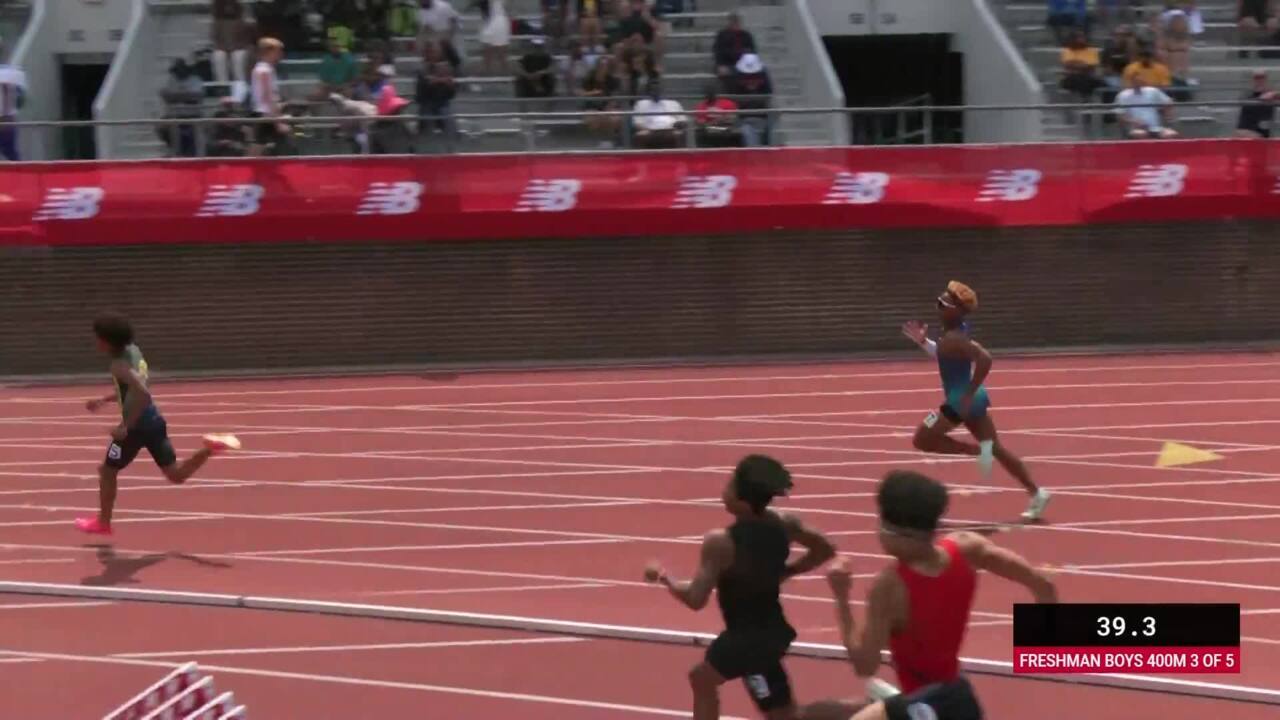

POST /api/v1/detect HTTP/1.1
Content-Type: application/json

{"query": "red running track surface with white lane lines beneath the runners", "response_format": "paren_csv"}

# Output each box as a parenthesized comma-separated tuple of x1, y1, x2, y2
(0, 355, 1280, 720)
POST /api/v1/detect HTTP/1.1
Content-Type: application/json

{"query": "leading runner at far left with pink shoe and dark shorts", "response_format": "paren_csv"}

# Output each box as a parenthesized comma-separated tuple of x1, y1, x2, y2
(76, 315, 239, 536)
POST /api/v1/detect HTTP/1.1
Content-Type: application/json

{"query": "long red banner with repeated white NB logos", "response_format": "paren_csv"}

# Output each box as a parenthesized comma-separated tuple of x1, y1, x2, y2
(0, 140, 1280, 245)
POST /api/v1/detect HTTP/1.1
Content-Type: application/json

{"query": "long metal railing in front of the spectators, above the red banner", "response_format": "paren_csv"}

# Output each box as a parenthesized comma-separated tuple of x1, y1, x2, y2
(0, 101, 1259, 161)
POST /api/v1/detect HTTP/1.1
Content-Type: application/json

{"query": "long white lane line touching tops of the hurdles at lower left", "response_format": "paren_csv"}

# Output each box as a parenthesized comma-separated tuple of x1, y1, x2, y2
(0, 648, 727, 720)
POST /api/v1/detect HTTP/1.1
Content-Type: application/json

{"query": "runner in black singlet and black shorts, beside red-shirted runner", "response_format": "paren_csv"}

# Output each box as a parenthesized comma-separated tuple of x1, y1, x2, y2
(645, 455, 836, 720)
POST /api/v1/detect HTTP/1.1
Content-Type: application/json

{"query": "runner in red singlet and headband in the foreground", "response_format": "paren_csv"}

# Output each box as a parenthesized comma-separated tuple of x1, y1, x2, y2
(801, 470, 1057, 720)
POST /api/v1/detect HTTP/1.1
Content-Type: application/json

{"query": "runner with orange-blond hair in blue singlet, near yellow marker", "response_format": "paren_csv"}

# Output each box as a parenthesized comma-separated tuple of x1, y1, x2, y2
(902, 281, 1050, 521)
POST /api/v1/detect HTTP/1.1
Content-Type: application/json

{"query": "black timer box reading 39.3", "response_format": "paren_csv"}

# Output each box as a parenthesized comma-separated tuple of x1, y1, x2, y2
(1014, 603, 1240, 647)
